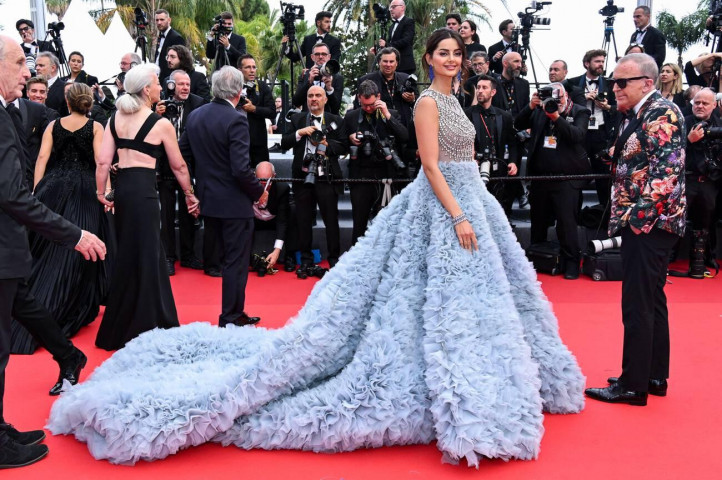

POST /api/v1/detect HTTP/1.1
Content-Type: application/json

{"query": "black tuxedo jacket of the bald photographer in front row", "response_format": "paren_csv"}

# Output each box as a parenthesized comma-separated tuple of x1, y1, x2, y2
(281, 112, 347, 182)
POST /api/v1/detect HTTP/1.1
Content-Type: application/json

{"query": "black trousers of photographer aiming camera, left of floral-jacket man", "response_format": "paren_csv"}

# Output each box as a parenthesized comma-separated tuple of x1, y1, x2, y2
(529, 181, 581, 261)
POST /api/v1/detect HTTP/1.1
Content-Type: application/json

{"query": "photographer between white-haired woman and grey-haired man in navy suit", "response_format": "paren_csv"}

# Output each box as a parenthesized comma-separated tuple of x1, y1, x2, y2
(155, 70, 205, 275)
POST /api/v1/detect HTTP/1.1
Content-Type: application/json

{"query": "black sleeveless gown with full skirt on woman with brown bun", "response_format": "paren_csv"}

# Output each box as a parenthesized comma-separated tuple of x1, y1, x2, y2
(12, 120, 112, 354)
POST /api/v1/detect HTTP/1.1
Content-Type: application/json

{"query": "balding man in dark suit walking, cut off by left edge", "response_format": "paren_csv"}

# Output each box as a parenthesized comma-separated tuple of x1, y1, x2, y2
(0, 36, 105, 468)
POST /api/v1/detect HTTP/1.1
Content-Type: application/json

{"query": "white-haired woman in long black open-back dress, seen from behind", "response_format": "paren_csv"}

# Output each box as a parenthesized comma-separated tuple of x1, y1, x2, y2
(95, 64, 200, 350)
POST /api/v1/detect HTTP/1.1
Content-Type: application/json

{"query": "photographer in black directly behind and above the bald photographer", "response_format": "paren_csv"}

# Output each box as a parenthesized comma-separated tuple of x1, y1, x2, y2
(291, 43, 343, 115)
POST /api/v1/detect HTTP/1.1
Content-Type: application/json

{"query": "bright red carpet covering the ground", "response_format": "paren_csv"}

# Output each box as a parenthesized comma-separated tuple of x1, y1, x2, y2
(5, 266, 722, 480)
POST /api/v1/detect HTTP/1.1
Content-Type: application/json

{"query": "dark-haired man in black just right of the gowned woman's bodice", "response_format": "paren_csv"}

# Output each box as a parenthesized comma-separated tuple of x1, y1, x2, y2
(466, 75, 521, 217)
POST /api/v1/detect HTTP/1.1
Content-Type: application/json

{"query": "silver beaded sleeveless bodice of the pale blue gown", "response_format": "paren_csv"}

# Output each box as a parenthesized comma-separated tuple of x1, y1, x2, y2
(414, 88, 475, 162)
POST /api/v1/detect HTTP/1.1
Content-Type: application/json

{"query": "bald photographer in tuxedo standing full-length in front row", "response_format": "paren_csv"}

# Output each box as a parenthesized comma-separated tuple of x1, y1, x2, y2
(281, 86, 346, 278)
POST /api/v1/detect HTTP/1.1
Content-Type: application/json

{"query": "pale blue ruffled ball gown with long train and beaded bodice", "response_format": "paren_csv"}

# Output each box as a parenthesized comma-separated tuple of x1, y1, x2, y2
(48, 90, 585, 466)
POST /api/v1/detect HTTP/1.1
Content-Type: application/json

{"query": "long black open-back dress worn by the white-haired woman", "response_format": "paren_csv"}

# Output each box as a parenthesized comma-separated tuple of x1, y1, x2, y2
(95, 115, 179, 350)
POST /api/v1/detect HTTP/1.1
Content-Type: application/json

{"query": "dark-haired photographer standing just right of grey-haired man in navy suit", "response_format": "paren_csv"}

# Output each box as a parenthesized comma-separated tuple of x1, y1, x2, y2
(236, 53, 276, 167)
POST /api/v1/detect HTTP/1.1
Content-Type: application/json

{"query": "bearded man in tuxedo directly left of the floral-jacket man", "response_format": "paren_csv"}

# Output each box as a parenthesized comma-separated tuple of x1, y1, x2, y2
(569, 50, 619, 206)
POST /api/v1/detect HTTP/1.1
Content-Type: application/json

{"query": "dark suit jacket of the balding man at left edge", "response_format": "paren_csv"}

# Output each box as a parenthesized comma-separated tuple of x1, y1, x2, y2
(0, 105, 81, 278)
